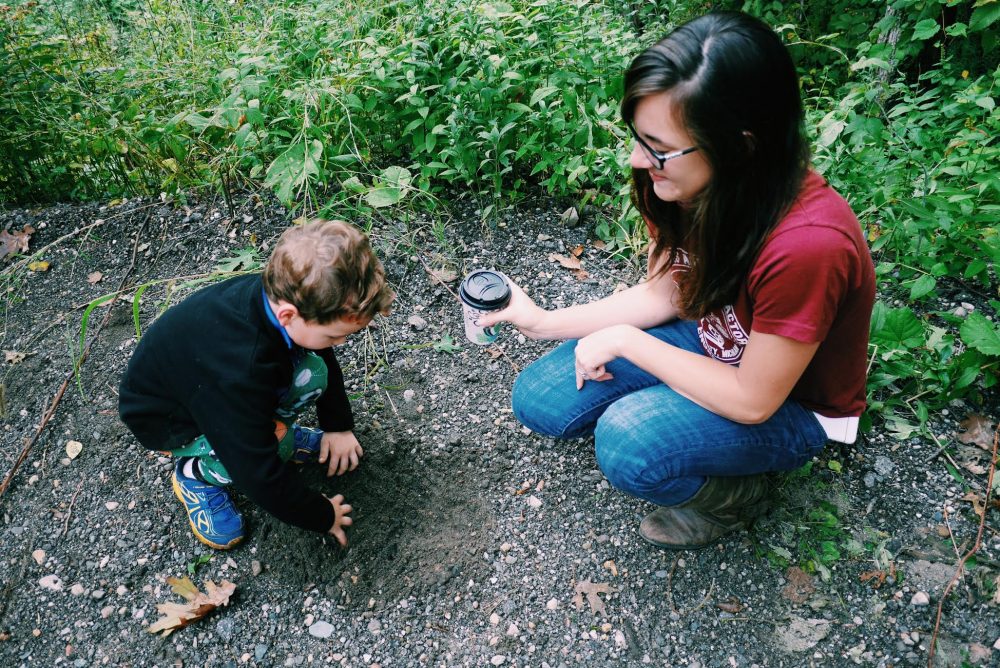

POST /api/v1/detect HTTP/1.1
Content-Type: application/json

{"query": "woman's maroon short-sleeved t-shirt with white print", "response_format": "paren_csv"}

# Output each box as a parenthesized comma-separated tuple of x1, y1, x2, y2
(664, 172, 875, 417)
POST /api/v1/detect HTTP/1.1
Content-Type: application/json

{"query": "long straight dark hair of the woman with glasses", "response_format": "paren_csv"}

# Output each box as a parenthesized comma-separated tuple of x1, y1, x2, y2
(621, 12, 809, 318)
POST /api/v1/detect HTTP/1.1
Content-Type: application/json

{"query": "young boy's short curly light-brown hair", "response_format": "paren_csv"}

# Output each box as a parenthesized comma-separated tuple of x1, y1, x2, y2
(264, 219, 396, 324)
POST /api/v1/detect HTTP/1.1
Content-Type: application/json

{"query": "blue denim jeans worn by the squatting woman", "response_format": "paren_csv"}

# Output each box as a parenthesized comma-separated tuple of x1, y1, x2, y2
(512, 320, 826, 506)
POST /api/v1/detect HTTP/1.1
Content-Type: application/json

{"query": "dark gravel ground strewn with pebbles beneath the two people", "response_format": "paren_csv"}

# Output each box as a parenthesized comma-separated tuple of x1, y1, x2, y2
(0, 190, 1000, 667)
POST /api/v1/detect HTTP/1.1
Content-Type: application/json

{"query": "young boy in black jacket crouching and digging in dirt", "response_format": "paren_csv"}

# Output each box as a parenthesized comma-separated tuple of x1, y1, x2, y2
(118, 220, 395, 550)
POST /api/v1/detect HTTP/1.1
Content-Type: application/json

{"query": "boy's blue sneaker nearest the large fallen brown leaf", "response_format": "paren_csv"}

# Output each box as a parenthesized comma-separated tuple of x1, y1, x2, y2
(173, 460, 243, 550)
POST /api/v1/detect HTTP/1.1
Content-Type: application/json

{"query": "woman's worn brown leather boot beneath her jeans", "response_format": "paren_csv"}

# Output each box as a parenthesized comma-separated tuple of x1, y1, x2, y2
(639, 473, 771, 550)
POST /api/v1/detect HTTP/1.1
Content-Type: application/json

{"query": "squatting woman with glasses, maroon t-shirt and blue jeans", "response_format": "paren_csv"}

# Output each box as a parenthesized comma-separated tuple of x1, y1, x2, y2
(480, 12, 875, 549)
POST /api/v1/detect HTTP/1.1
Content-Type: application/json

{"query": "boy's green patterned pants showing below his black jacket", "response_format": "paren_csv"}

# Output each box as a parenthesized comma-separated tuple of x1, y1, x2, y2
(169, 351, 327, 486)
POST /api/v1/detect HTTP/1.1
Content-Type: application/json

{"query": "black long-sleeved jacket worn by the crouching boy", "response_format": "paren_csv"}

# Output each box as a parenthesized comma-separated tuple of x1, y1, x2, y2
(118, 275, 354, 532)
